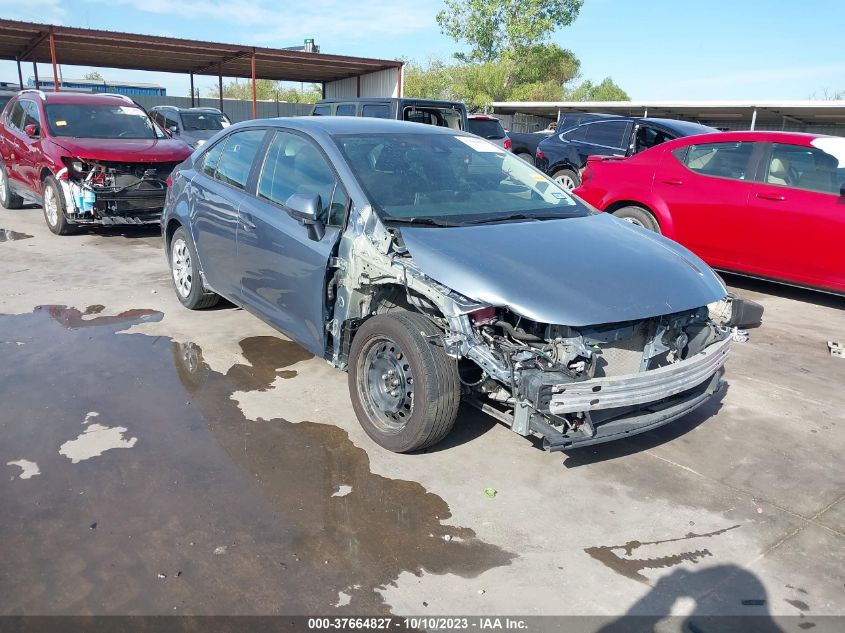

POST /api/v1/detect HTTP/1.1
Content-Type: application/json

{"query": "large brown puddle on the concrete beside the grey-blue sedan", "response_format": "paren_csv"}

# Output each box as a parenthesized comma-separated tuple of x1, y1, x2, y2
(0, 306, 513, 614)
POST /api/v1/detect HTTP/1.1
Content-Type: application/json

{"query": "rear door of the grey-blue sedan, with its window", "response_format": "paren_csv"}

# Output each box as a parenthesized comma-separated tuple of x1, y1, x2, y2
(191, 129, 266, 299)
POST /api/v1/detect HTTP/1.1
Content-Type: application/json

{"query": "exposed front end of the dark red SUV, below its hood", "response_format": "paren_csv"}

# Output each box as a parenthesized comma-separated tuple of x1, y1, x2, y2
(59, 159, 178, 224)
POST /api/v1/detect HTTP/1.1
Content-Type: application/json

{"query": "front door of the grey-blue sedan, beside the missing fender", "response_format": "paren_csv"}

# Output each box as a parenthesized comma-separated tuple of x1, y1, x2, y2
(238, 130, 349, 357)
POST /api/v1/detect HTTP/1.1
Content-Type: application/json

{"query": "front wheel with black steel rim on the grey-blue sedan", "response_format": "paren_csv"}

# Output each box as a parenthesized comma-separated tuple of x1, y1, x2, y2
(349, 310, 461, 453)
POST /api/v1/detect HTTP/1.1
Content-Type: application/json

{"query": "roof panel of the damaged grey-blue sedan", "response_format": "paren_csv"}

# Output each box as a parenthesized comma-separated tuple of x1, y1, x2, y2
(237, 116, 468, 136)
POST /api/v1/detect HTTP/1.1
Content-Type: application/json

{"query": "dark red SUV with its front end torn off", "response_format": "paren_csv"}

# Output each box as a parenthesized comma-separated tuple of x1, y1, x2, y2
(0, 90, 191, 235)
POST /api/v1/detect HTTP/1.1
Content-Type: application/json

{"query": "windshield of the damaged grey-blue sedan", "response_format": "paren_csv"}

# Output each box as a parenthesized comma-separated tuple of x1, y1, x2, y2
(335, 134, 589, 224)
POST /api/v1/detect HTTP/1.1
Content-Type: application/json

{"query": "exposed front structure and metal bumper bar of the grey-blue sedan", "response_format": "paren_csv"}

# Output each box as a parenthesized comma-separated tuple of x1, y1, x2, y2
(326, 204, 731, 450)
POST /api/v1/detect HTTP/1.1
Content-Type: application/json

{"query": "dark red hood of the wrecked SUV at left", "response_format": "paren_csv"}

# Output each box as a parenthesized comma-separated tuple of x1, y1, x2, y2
(50, 137, 191, 163)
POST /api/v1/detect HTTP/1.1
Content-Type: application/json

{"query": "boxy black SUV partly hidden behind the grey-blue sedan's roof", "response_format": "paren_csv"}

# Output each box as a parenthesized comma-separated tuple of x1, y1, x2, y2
(311, 97, 467, 130)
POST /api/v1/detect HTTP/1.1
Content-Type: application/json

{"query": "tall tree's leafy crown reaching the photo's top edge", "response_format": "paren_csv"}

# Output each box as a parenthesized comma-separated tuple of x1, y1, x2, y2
(437, 0, 584, 62)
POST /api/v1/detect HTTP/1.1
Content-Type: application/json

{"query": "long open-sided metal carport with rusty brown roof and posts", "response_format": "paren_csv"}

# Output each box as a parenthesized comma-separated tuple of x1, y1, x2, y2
(0, 19, 402, 118)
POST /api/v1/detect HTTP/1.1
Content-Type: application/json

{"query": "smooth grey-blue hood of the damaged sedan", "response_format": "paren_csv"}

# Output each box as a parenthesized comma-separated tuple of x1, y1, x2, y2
(401, 213, 726, 327)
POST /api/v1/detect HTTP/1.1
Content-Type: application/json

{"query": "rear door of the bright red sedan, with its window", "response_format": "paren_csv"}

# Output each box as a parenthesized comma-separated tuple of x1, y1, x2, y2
(653, 142, 759, 270)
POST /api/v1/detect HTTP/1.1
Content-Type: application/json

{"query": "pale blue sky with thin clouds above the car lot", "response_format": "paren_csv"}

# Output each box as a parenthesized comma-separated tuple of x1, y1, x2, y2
(0, 0, 845, 100)
